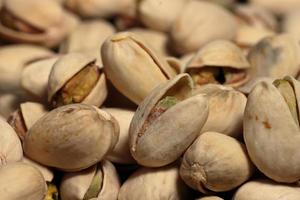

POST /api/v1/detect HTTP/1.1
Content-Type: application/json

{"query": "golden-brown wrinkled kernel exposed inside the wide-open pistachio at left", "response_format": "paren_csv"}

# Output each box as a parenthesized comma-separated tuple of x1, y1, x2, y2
(51, 61, 101, 108)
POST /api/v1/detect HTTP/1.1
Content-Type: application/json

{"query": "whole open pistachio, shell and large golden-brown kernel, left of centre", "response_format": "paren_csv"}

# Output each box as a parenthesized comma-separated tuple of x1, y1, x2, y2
(48, 53, 107, 107)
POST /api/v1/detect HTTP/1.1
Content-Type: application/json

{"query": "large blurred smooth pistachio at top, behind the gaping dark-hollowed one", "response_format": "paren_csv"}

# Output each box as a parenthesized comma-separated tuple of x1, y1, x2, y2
(171, 0, 238, 54)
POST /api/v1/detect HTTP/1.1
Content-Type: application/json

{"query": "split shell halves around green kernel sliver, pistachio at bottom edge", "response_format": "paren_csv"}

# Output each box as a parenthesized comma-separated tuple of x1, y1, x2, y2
(60, 160, 121, 200)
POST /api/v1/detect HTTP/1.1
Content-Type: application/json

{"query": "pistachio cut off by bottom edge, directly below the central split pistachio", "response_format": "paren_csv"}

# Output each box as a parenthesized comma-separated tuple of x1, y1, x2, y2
(118, 165, 191, 200)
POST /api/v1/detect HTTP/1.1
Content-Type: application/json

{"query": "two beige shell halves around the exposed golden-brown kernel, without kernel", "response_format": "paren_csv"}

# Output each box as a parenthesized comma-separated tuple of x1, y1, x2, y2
(48, 53, 107, 106)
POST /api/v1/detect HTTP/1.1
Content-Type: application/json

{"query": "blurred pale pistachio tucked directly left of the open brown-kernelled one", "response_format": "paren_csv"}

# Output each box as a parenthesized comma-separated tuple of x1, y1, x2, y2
(21, 57, 59, 100)
